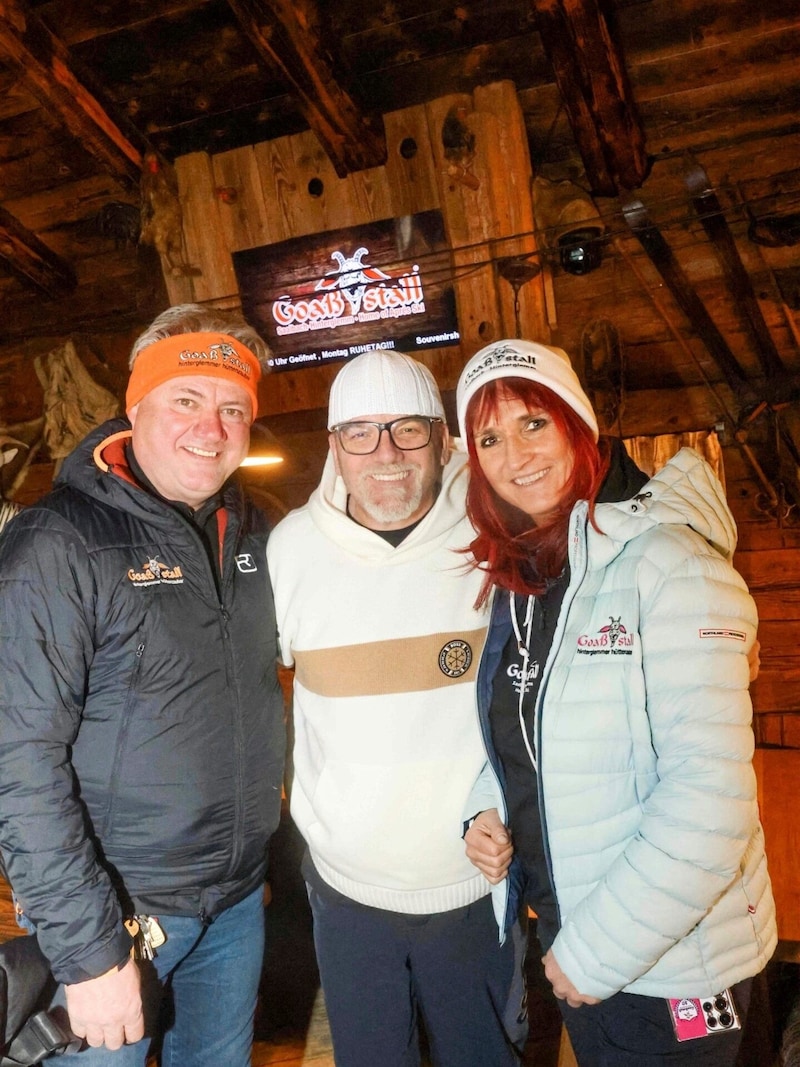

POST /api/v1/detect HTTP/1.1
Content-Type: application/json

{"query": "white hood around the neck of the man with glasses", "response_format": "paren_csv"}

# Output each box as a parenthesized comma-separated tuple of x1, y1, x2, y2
(306, 439, 471, 564)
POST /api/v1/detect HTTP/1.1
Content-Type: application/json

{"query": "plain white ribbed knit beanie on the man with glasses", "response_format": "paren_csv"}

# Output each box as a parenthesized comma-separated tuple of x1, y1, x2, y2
(327, 348, 445, 430)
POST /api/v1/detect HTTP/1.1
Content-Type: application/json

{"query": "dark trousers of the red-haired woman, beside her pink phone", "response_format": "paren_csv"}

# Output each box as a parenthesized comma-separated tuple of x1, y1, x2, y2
(558, 978, 753, 1067)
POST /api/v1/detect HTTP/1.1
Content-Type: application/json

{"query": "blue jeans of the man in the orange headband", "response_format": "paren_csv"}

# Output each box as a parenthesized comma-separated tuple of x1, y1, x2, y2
(48, 889, 263, 1067)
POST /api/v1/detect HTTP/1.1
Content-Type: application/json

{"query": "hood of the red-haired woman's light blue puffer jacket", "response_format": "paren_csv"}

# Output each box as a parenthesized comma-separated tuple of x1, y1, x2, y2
(595, 448, 736, 563)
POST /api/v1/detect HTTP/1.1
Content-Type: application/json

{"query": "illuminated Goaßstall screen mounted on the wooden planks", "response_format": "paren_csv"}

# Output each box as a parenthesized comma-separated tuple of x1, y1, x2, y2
(234, 211, 460, 370)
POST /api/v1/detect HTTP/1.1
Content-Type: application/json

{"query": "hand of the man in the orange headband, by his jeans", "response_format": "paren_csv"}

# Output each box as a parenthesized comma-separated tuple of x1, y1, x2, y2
(64, 959, 144, 1051)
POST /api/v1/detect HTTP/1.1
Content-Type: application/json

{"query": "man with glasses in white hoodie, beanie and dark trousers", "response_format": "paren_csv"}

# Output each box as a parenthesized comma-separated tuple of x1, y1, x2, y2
(268, 350, 526, 1067)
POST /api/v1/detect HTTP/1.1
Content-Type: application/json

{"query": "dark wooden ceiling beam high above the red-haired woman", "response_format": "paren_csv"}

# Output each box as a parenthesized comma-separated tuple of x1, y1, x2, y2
(530, 0, 650, 196)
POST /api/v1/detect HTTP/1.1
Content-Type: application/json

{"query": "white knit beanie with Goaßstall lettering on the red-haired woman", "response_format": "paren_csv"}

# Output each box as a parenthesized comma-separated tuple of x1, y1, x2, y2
(455, 340, 599, 441)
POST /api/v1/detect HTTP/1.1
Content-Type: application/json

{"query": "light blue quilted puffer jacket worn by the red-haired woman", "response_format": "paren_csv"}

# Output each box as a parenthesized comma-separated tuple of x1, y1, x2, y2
(470, 449, 777, 999)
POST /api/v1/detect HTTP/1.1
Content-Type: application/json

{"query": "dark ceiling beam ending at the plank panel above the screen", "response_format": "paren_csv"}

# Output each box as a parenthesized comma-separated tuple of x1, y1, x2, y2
(228, 0, 386, 178)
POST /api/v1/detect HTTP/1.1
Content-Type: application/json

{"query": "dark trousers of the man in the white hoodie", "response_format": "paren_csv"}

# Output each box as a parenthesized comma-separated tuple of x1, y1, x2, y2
(308, 886, 527, 1067)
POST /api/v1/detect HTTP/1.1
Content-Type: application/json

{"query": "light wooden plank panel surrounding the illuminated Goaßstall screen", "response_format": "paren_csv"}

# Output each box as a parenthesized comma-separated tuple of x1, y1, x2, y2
(166, 82, 547, 416)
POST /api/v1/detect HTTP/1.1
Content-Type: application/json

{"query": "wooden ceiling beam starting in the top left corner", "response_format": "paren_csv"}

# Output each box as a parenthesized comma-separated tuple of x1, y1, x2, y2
(0, 0, 147, 186)
